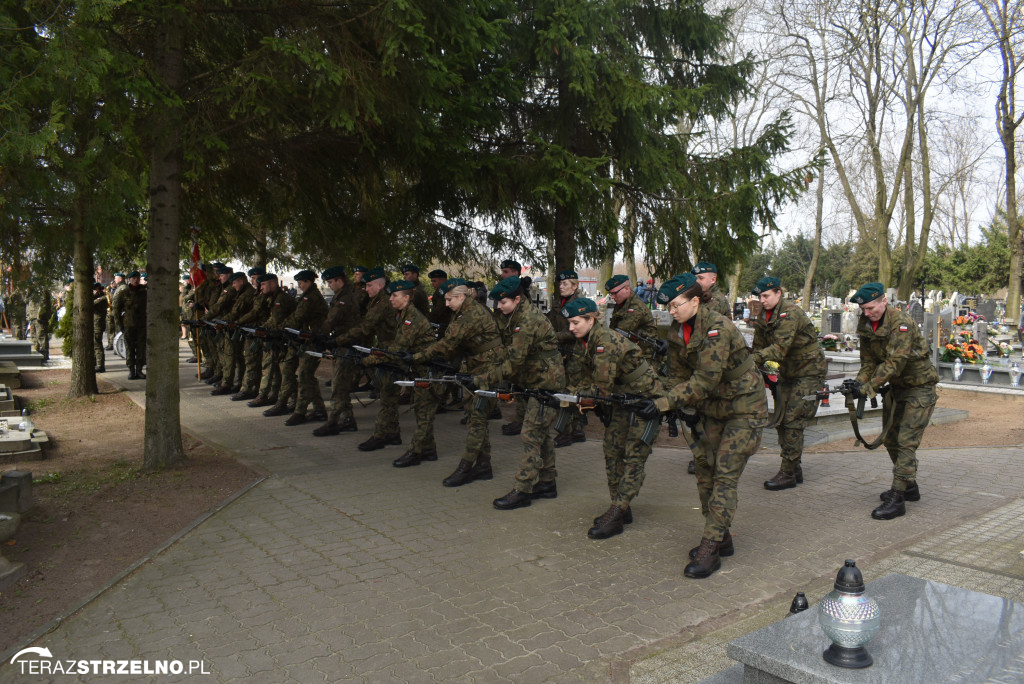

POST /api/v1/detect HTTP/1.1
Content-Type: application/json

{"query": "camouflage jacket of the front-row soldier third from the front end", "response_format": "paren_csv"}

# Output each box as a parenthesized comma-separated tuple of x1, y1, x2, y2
(483, 299, 565, 390)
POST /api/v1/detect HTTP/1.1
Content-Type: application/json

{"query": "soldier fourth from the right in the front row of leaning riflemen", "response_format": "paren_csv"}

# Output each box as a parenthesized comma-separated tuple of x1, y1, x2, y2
(413, 277, 505, 486)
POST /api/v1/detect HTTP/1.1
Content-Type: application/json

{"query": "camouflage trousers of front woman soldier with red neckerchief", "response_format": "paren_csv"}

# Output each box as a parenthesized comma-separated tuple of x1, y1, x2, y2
(693, 417, 763, 542)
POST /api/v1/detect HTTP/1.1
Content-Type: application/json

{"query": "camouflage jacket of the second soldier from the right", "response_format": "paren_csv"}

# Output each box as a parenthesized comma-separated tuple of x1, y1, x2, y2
(751, 299, 826, 383)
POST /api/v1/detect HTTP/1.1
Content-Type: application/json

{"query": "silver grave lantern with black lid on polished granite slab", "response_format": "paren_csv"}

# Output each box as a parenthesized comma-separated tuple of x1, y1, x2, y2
(818, 560, 882, 669)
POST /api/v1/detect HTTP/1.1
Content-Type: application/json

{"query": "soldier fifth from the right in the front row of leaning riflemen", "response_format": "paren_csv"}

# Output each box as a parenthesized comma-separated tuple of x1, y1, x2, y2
(362, 281, 437, 468)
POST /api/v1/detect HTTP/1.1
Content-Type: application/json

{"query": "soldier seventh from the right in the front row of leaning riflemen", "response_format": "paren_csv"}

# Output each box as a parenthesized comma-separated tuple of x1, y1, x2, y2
(313, 266, 366, 437)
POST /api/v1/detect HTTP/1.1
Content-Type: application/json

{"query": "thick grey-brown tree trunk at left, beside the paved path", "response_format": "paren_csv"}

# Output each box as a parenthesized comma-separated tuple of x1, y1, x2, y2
(142, 7, 184, 470)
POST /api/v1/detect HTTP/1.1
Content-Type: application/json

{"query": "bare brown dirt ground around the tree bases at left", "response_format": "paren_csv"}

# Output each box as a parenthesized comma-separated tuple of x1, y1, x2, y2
(0, 370, 257, 651)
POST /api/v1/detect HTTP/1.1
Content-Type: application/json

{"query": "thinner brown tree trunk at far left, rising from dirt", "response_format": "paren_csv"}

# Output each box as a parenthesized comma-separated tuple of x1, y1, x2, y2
(69, 219, 98, 398)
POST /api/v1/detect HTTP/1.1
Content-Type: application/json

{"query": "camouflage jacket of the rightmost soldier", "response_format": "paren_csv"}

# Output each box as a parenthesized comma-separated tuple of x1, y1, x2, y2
(857, 306, 939, 396)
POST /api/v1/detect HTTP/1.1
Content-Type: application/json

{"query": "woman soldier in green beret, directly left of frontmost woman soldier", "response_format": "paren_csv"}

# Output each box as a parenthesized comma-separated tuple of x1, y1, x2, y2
(562, 297, 666, 540)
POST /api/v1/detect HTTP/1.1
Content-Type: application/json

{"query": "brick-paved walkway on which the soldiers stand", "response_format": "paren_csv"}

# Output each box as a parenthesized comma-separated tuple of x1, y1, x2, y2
(0, 344, 1024, 682)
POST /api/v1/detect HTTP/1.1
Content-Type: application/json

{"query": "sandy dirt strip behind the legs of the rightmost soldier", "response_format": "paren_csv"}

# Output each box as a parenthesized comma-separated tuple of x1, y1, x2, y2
(804, 387, 1024, 454)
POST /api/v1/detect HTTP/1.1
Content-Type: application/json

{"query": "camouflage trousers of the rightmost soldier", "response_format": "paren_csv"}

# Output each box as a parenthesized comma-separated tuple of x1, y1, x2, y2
(882, 385, 939, 491)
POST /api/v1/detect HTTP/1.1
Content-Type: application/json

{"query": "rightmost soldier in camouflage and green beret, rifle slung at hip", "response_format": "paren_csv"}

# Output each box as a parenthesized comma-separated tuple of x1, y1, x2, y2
(850, 283, 939, 520)
